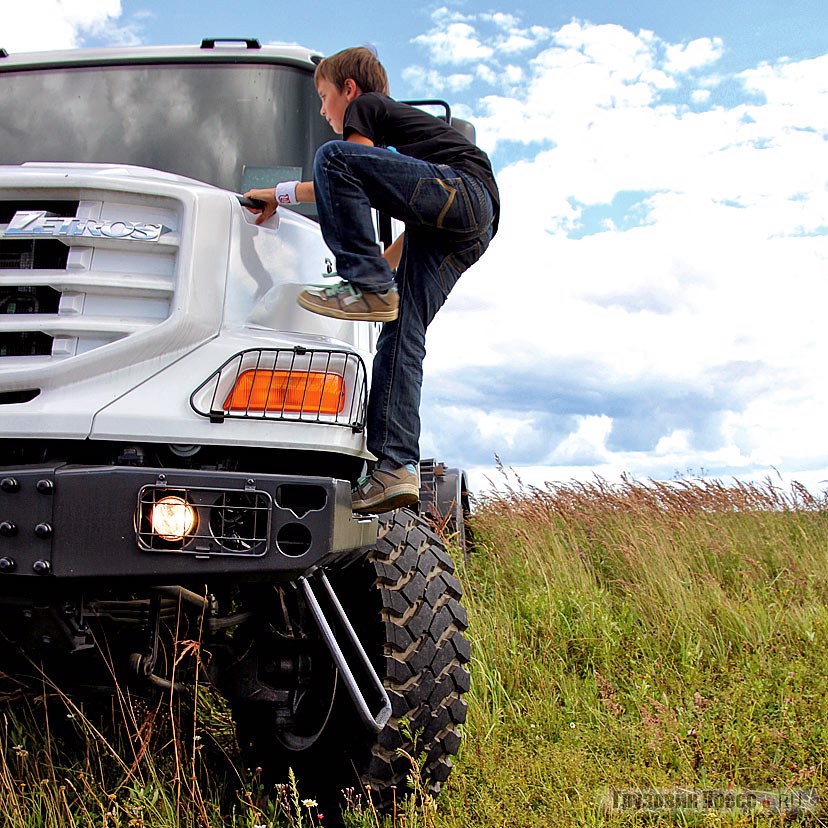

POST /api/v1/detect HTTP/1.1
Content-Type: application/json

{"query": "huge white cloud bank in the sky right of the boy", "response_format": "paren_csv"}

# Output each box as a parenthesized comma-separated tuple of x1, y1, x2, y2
(414, 17, 828, 486)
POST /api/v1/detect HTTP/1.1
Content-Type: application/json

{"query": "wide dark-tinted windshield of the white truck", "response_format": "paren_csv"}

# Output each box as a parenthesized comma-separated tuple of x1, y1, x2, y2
(0, 63, 335, 200)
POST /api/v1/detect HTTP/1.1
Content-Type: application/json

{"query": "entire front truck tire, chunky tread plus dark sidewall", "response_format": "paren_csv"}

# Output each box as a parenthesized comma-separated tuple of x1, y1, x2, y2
(234, 509, 470, 809)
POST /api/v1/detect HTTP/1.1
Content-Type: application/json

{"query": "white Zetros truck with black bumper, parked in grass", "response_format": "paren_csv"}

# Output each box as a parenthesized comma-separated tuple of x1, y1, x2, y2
(0, 39, 470, 804)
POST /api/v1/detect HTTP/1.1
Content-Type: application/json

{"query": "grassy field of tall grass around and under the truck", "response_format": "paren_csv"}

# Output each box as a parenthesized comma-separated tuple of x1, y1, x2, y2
(0, 481, 828, 828)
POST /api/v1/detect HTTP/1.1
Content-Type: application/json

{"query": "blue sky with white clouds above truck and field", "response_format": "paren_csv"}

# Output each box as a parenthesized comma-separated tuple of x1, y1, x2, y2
(0, 0, 828, 494)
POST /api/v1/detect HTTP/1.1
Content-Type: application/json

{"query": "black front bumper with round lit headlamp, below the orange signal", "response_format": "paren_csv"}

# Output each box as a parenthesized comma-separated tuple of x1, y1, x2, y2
(0, 465, 377, 591)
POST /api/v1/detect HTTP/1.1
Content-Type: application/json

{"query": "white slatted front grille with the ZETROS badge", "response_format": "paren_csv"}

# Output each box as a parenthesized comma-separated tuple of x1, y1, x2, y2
(0, 199, 178, 359)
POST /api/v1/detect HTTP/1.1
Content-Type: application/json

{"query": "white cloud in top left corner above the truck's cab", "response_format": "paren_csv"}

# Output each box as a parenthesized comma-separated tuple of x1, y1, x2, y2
(0, 0, 138, 52)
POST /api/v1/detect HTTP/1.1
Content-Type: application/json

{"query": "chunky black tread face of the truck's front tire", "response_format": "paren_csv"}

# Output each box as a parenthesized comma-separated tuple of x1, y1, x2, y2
(362, 510, 469, 795)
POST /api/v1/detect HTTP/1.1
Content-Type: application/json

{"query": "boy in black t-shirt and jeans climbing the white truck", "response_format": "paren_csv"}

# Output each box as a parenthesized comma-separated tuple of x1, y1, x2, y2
(245, 47, 500, 513)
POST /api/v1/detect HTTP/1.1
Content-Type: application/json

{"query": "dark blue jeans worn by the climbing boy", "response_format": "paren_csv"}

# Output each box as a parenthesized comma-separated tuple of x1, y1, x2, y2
(313, 141, 493, 466)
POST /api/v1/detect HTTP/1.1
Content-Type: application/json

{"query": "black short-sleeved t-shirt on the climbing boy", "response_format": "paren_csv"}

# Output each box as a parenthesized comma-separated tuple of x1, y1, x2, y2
(342, 92, 500, 234)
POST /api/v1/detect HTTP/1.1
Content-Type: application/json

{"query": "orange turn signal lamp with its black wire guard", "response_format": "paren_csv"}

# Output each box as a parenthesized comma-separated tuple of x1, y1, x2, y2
(190, 348, 368, 431)
